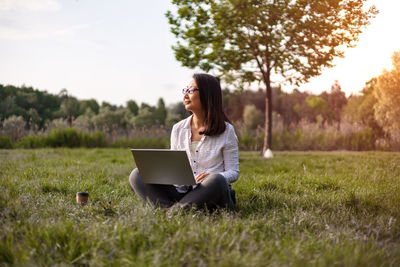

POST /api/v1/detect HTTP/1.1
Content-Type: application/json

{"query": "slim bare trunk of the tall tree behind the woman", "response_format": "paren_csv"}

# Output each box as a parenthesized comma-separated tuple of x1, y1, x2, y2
(262, 72, 272, 156)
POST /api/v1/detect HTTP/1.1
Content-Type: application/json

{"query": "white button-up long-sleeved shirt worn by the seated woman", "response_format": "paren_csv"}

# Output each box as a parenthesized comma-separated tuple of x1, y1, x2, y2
(171, 115, 239, 186)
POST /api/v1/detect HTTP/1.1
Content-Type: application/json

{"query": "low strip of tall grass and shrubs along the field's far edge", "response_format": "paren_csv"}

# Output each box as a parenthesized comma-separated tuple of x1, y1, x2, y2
(0, 120, 400, 151)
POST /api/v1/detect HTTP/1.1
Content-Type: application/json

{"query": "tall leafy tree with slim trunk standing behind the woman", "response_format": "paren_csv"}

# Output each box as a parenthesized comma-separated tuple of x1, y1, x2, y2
(166, 0, 377, 156)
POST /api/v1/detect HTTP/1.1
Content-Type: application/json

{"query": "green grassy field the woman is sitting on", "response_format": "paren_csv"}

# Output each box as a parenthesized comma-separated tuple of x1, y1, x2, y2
(0, 149, 400, 266)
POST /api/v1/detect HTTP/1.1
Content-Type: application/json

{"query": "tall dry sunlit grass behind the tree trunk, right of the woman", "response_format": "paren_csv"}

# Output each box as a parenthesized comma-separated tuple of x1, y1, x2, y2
(238, 123, 400, 151)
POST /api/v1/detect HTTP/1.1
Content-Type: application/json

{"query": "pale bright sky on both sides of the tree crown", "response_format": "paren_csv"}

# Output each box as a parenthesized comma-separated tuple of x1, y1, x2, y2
(0, 0, 400, 105)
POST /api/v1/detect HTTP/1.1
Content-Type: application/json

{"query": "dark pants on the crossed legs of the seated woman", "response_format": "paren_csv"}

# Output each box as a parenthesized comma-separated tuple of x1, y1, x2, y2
(129, 168, 234, 210)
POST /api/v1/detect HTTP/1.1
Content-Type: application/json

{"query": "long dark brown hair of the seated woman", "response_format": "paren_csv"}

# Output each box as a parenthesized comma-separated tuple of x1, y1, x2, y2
(193, 73, 230, 136)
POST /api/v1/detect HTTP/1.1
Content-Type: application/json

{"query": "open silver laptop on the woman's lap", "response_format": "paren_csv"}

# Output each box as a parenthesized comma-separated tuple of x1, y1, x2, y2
(131, 149, 196, 185)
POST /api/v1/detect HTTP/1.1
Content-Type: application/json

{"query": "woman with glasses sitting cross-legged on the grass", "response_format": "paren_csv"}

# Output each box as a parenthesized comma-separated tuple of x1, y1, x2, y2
(129, 74, 239, 210)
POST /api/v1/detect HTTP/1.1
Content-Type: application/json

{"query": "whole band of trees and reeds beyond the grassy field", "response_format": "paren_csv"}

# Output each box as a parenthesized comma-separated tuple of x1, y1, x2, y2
(0, 71, 399, 150)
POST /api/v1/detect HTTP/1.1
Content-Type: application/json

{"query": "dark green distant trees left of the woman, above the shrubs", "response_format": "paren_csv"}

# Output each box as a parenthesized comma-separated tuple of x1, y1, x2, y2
(0, 84, 187, 129)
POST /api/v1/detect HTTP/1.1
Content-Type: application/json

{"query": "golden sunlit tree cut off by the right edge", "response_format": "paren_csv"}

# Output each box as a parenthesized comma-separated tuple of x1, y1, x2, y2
(374, 50, 400, 141)
